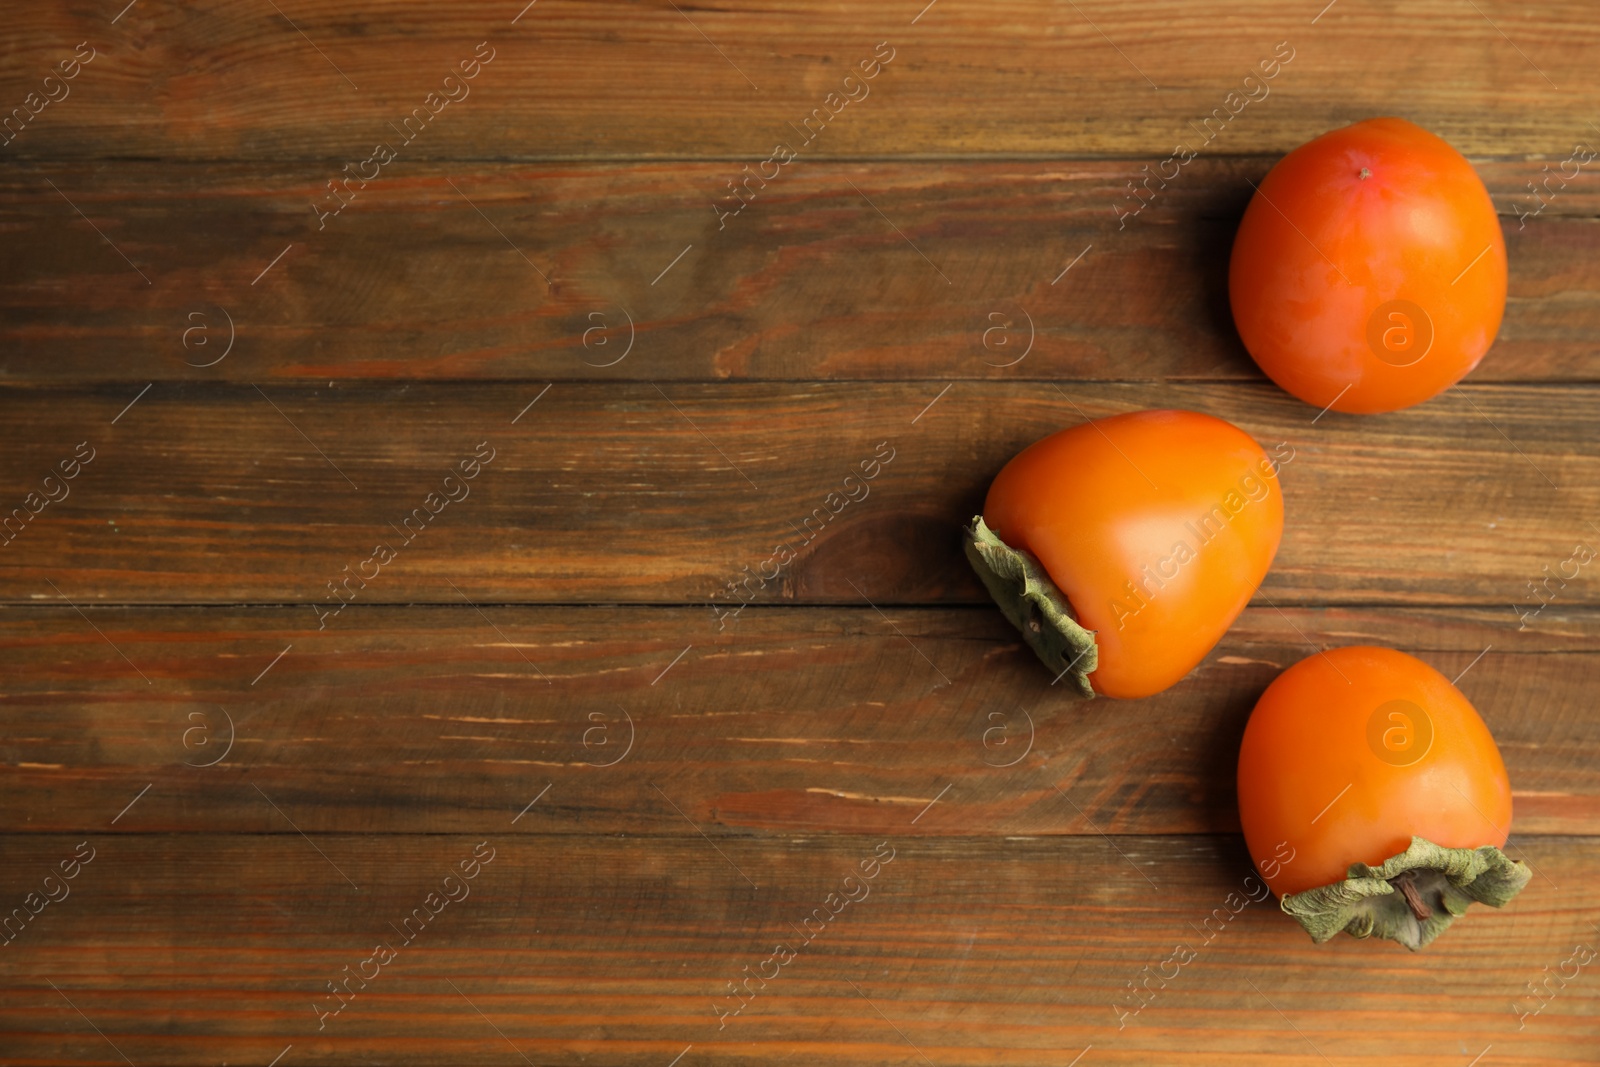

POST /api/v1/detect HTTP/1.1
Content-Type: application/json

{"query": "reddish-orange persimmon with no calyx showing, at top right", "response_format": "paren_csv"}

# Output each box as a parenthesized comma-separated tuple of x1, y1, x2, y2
(1227, 118, 1506, 411)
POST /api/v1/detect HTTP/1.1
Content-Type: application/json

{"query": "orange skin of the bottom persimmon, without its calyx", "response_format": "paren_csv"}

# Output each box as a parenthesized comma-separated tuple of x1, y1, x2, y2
(1238, 646, 1510, 896)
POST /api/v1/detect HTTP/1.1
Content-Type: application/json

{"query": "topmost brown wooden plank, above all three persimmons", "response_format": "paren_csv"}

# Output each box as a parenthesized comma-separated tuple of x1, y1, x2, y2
(0, 0, 1600, 163)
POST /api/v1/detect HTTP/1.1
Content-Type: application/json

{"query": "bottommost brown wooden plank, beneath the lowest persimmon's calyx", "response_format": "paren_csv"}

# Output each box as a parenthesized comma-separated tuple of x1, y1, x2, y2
(0, 838, 1600, 1067)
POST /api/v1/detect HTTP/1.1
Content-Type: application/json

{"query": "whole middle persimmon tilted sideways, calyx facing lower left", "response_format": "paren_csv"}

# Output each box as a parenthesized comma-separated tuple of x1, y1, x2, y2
(966, 411, 1293, 697)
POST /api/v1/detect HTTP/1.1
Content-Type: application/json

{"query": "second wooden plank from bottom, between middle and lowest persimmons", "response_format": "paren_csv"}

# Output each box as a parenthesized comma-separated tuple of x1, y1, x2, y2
(0, 605, 1600, 837)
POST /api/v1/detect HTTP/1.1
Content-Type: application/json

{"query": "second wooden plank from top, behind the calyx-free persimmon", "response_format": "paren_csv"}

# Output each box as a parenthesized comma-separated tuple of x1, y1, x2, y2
(0, 163, 1600, 384)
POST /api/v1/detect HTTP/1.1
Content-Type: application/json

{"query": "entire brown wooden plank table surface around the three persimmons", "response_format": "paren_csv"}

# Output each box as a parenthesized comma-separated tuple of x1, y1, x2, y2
(0, 0, 1600, 1067)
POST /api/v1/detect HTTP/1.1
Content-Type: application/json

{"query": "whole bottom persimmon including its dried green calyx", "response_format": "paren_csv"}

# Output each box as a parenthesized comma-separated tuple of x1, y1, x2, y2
(1238, 646, 1531, 949)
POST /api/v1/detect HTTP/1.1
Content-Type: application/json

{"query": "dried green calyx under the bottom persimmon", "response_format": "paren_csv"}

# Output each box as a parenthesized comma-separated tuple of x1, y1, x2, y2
(1280, 837, 1533, 952)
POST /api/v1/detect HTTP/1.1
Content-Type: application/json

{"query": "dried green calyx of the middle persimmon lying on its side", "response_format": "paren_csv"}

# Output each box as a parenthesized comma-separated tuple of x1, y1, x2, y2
(966, 515, 1099, 697)
